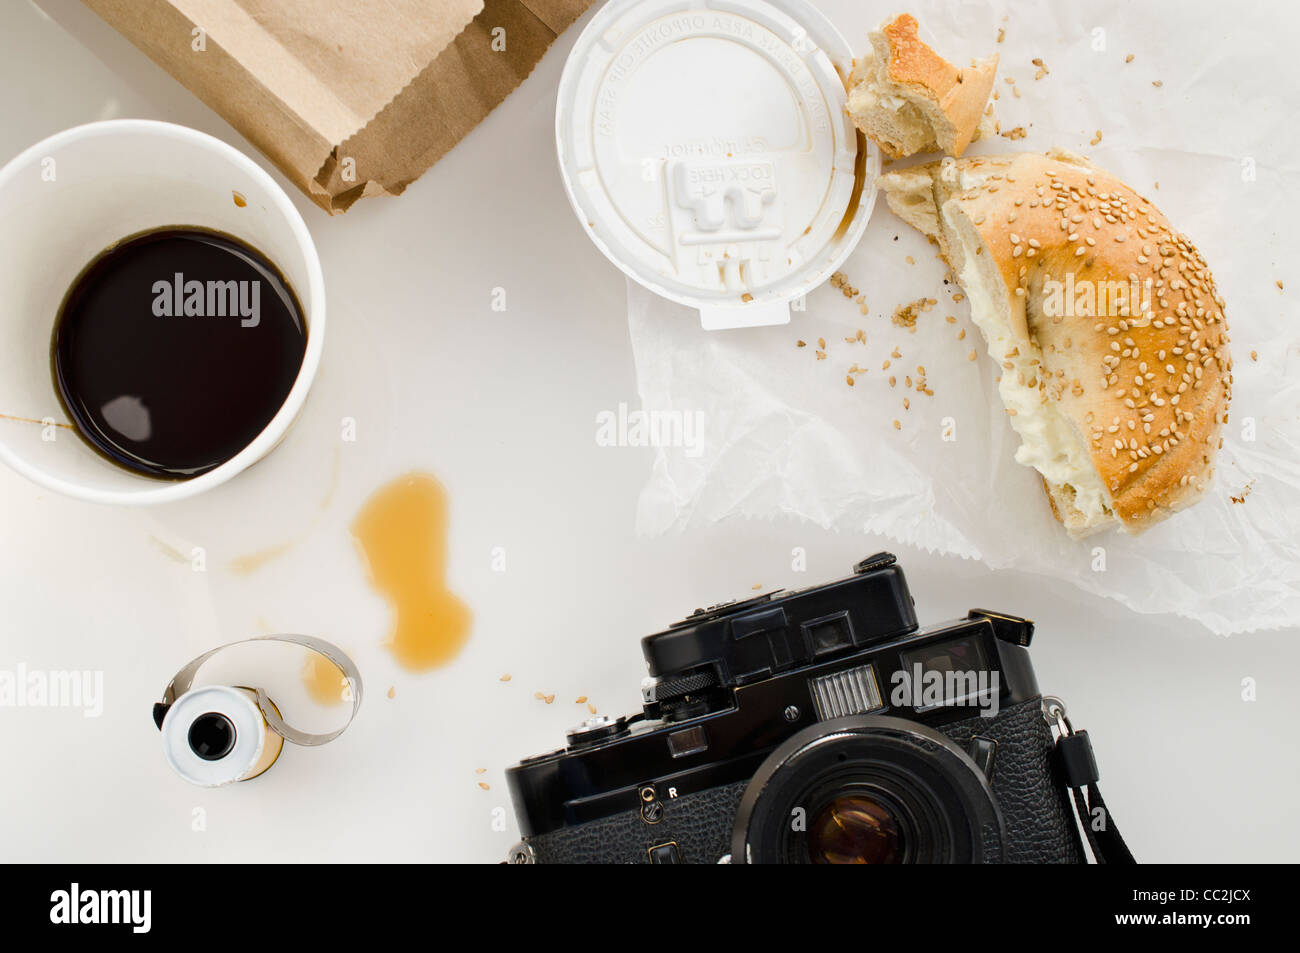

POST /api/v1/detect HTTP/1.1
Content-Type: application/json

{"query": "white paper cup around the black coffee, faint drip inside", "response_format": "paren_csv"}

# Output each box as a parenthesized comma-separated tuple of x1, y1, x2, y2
(0, 120, 325, 504)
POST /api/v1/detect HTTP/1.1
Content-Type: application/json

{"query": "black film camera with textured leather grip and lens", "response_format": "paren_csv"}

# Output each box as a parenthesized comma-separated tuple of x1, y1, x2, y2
(507, 554, 1083, 863)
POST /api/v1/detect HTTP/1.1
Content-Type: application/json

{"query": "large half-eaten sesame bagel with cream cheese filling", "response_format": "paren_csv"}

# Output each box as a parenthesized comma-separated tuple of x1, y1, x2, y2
(880, 152, 1232, 537)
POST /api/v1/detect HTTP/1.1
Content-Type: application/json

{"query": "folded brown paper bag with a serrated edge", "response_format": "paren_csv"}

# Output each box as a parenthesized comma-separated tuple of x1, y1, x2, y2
(83, 0, 593, 213)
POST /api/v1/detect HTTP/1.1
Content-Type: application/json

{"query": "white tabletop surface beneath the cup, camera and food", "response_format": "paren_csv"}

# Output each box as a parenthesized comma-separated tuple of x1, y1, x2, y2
(0, 0, 1300, 862)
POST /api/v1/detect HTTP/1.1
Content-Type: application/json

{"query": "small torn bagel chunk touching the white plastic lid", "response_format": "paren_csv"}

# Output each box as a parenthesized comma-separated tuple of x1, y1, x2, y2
(848, 13, 997, 159)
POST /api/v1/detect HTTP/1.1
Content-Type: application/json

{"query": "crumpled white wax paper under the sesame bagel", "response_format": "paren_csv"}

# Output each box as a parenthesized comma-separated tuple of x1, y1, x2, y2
(628, 0, 1300, 634)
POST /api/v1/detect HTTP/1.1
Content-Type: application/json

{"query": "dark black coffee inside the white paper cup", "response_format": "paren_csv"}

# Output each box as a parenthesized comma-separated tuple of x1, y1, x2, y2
(51, 226, 307, 480)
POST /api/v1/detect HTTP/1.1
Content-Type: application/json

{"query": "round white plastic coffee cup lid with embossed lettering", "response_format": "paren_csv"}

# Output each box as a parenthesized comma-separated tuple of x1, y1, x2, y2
(555, 0, 880, 328)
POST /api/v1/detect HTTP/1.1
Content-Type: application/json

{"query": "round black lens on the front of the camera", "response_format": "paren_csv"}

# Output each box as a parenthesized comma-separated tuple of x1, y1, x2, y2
(732, 715, 1005, 863)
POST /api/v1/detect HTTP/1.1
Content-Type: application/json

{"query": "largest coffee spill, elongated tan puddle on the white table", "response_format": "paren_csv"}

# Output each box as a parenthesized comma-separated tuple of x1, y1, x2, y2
(352, 473, 473, 671)
